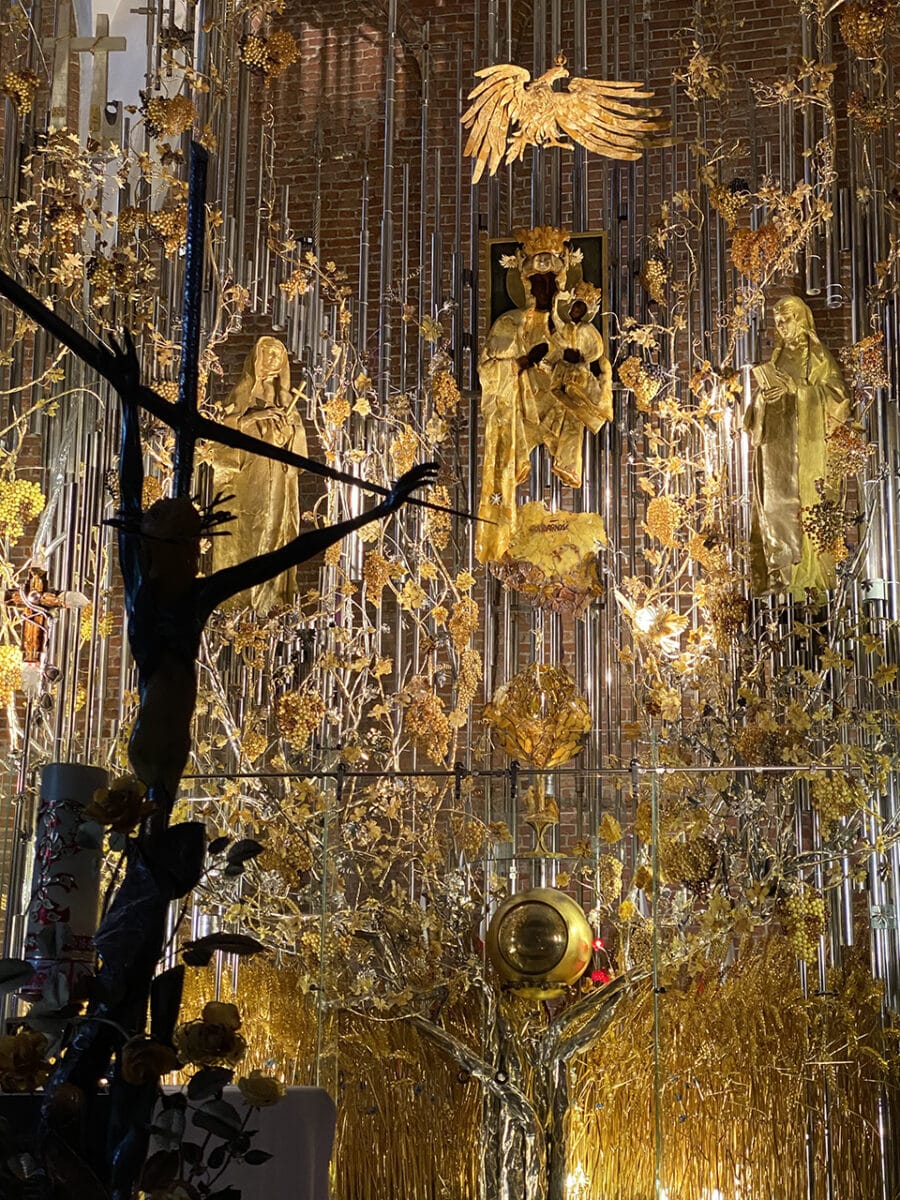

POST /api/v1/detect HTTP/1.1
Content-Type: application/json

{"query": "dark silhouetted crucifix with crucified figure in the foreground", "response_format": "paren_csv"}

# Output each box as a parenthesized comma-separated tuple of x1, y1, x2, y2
(0, 144, 468, 1200)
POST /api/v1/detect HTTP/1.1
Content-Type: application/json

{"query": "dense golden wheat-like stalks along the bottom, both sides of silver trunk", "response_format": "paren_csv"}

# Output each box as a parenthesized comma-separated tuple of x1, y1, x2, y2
(184, 935, 898, 1200)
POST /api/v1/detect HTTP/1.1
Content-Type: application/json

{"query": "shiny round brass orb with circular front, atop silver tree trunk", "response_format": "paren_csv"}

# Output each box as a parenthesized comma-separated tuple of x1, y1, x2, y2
(487, 888, 594, 1000)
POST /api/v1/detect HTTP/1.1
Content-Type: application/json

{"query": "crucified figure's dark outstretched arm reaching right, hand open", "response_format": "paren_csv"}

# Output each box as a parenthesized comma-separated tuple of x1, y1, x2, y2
(197, 462, 438, 622)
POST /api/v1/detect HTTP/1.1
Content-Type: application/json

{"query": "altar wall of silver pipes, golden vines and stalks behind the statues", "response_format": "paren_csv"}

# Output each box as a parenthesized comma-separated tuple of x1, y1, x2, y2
(0, 0, 900, 1200)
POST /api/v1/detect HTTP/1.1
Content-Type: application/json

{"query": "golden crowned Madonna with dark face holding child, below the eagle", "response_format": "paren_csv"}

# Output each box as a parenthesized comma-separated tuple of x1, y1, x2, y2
(475, 226, 612, 563)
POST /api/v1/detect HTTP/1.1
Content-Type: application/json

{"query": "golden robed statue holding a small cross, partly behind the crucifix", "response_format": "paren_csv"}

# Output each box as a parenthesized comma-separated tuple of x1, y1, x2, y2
(212, 337, 306, 613)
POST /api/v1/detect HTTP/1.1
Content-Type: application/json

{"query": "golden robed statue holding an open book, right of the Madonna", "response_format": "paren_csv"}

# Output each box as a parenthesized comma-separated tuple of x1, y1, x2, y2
(744, 296, 850, 599)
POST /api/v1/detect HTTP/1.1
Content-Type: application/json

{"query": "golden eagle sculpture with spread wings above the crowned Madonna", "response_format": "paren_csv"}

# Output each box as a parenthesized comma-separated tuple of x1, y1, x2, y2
(461, 54, 668, 184)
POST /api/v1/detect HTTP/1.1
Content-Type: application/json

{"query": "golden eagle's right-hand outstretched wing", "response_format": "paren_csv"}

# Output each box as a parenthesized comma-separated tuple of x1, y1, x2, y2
(553, 79, 668, 160)
